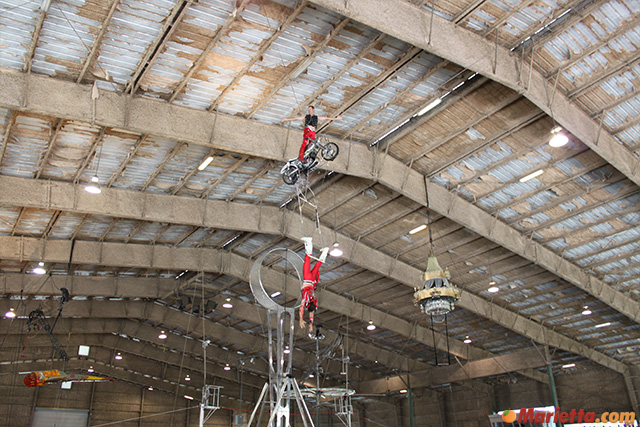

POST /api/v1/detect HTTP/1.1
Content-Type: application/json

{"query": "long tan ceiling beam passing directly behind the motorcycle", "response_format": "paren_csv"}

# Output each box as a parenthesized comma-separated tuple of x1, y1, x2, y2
(0, 75, 640, 338)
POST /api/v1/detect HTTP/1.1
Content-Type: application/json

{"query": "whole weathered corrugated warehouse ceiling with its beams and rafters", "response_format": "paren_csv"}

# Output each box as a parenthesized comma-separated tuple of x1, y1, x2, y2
(0, 0, 640, 404)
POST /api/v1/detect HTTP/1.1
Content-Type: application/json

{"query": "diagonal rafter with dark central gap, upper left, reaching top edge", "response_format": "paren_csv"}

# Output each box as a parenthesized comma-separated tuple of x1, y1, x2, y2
(122, 0, 193, 94)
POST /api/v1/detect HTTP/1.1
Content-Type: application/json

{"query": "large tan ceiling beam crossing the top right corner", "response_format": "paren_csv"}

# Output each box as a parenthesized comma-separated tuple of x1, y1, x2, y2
(312, 0, 640, 185)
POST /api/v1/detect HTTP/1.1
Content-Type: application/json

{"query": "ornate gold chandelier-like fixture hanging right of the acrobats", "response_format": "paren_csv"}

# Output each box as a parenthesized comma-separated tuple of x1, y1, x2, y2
(413, 181, 460, 316)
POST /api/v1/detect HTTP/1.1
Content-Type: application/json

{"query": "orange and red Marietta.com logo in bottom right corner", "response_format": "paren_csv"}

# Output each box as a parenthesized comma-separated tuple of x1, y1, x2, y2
(502, 408, 636, 425)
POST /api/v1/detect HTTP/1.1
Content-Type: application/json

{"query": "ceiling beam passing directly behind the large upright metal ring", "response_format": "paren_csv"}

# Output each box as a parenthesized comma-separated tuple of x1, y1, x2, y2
(0, 232, 528, 370)
